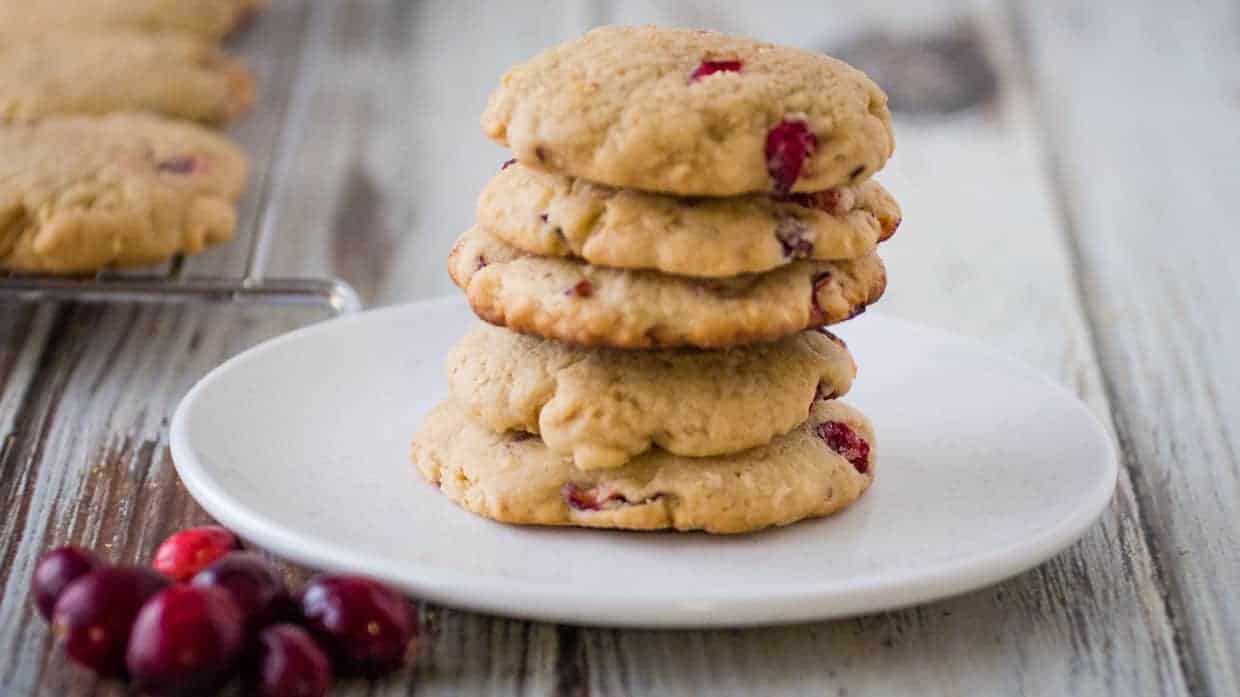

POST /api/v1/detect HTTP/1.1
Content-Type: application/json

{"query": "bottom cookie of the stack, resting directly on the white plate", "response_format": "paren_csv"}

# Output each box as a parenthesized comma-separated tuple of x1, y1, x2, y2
(413, 399, 874, 533)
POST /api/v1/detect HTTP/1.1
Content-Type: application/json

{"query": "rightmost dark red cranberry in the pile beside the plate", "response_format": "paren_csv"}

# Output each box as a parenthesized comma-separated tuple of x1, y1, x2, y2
(301, 575, 417, 677)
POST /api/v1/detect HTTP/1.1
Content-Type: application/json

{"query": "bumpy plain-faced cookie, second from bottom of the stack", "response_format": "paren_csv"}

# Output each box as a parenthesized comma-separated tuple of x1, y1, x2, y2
(448, 324, 857, 469)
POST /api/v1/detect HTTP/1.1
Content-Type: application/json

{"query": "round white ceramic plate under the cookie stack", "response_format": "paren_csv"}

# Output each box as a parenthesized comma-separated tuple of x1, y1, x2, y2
(171, 299, 1116, 626)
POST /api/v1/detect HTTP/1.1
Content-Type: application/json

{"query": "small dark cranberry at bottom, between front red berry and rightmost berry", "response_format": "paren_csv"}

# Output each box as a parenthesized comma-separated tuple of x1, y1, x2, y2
(246, 624, 331, 697)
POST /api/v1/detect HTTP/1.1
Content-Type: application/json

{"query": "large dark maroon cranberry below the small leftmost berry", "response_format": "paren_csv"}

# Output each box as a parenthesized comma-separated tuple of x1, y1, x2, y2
(52, 567, 167, 677)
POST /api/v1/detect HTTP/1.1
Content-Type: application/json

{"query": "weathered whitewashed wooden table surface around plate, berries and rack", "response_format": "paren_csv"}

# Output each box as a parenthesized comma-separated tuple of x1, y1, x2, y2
(0, 0, 1240, 697)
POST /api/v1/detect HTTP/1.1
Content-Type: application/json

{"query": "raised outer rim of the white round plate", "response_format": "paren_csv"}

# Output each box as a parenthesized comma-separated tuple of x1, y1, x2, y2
(170, 295, 1118, 629)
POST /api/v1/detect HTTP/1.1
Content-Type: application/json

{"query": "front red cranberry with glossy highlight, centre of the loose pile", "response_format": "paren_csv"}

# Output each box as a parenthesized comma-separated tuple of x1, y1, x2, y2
(125, 585, 246, 697)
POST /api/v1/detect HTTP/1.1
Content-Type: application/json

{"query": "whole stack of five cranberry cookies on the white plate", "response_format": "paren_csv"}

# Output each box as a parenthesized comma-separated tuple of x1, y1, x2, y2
(413, 27, 900, 533)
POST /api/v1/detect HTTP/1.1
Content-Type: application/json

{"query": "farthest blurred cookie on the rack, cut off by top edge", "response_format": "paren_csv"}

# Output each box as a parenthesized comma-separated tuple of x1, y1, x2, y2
(0, 0, 265, 38)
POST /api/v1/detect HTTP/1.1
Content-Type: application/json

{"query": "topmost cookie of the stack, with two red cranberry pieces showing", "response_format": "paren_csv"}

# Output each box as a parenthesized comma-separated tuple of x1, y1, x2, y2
(482, 26, 894, 196)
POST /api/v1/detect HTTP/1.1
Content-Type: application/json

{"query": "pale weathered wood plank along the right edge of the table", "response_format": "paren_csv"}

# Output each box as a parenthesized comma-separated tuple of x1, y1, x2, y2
(1023, 1, 1240, 695)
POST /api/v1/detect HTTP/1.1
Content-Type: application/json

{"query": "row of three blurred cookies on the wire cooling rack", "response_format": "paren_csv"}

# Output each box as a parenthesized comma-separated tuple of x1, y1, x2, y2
(0, 0, 263, 274)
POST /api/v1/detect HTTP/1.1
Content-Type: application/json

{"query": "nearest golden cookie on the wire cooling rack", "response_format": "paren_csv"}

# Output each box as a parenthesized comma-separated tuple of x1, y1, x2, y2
(0, 114, 246, 273)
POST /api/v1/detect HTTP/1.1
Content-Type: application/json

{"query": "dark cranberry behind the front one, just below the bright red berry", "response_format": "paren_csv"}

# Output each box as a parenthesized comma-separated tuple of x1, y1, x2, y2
(192, 552, 295, 635)
